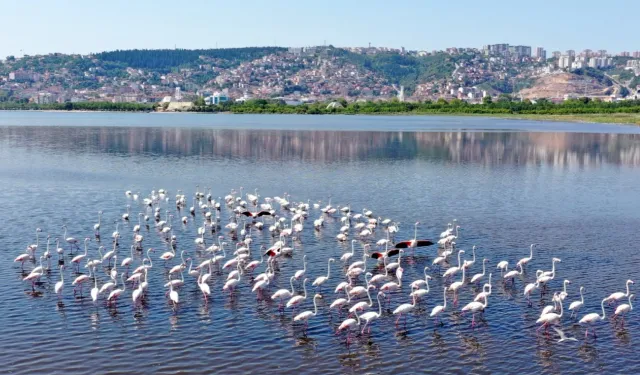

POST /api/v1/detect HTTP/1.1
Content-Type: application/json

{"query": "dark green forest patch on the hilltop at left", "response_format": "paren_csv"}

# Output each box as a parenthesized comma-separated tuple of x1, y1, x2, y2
(95, 47, 286, 71)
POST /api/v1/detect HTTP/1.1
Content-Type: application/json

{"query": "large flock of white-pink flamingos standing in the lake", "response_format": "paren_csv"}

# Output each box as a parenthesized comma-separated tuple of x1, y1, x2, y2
(15, 187, 634, 343)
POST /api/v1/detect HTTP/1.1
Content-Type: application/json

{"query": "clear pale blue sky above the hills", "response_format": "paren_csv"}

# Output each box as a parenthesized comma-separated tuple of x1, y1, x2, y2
(0, 0, 640, 58)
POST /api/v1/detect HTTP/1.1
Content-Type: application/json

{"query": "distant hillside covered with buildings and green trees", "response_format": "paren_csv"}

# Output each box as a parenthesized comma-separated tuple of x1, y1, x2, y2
(0, 44, 640, 105)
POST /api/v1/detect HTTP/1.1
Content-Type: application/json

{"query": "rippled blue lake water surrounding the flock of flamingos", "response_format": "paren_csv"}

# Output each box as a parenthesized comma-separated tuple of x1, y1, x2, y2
(0, 112, 640, 374)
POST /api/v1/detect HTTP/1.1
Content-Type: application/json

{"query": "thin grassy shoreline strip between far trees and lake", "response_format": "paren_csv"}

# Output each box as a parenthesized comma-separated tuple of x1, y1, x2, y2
(0, 109, 640, 125)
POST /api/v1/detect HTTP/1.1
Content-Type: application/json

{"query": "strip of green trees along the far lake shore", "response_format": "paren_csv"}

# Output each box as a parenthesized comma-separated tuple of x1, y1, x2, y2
(0, 98, 640, 125)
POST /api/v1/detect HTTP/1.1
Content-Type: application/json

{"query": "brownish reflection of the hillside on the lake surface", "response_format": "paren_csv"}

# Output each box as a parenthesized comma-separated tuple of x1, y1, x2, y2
(0, 127, 640, 166)
